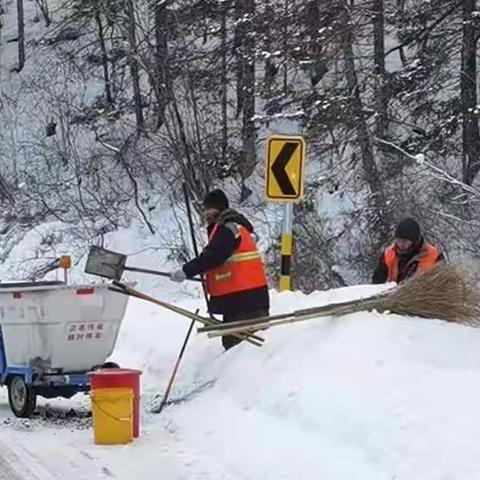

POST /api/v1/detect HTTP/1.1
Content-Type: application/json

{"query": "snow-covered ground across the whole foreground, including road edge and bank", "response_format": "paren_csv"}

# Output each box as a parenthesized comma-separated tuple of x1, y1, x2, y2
(0, 284, 480, 480)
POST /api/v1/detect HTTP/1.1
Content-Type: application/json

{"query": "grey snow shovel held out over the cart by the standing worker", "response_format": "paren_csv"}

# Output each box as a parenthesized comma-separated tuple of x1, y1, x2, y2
(85, 245, 202, 282)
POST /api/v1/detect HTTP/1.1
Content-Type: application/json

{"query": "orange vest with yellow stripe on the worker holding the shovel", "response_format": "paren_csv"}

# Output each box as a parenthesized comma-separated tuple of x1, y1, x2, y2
(206, 225, 267, 297)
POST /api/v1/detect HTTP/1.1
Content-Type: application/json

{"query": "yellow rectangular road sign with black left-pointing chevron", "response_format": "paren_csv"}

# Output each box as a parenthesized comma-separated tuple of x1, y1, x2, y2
(266, 135, 306, 202)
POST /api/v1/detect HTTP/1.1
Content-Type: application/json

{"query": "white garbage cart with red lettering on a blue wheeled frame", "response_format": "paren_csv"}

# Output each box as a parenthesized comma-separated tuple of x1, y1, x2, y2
(0, 282, 128, 418)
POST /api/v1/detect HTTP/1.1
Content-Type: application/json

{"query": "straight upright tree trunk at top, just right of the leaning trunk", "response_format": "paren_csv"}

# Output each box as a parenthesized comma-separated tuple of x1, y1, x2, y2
(373, 0, 388, 138)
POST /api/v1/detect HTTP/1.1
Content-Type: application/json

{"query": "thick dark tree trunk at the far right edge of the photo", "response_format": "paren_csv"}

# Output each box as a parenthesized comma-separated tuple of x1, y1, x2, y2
(460, 0, 480, 185)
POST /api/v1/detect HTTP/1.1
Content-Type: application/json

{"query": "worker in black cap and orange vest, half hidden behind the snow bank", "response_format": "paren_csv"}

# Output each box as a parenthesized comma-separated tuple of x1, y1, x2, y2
(373, 218, 444, 283)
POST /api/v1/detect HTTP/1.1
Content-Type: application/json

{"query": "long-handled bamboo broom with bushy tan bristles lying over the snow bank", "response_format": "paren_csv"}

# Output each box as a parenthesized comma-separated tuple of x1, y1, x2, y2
(199, 263, 480, 338)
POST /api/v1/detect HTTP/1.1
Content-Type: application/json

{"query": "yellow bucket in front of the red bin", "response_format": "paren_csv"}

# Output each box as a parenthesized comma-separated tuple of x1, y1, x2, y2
(90, 388, 133, 445)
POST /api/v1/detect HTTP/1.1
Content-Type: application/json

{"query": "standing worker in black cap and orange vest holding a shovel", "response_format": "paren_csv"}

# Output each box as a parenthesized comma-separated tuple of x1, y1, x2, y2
(170, 190, 270, 349)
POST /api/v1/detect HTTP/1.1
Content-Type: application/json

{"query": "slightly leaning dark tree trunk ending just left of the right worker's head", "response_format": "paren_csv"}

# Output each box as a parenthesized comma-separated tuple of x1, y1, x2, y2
(341, 2, 391, 243)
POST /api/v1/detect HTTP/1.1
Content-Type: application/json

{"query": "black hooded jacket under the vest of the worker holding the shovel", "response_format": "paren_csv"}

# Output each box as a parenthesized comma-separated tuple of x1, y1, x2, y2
(183, 209, 270, 315)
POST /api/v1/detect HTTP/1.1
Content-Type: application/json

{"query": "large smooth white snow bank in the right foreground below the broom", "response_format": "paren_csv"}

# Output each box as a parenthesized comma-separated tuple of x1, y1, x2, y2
(131, 288, 480, 480)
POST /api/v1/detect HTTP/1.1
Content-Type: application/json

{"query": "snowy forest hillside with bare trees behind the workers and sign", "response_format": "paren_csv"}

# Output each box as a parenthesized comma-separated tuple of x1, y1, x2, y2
(0, 0, 480, 291)
